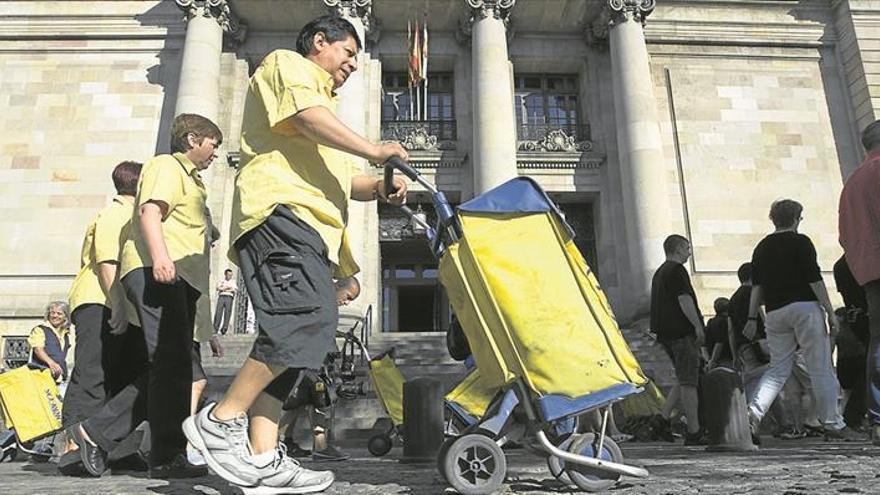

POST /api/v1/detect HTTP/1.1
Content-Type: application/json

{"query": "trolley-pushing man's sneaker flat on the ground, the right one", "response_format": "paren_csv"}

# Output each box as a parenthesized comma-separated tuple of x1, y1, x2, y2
(242, 444, 336, 495)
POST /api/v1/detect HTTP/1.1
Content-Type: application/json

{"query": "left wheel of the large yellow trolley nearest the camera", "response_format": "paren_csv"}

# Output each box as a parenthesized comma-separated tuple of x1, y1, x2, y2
(443, 433, 507, 495)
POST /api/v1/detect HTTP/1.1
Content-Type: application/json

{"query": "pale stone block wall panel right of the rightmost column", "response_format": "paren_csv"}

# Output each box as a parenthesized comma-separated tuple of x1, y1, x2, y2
(652, 51, 842, 313)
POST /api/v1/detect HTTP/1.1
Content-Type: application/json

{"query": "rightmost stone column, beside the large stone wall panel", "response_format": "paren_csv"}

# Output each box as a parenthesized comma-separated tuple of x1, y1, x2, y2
(605, 0, 671, 317)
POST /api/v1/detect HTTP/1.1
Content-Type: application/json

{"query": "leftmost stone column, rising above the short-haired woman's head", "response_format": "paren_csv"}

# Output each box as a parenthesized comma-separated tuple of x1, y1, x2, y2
(174, 0, 243, 121)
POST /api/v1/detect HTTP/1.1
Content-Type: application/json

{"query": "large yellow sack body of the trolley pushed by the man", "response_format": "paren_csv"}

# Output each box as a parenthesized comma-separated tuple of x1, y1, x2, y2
(440, 211, 646, 398)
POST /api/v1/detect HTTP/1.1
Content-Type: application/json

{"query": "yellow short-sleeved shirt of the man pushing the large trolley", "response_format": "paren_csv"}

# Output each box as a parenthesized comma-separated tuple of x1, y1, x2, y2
(230, 50, 363, 265)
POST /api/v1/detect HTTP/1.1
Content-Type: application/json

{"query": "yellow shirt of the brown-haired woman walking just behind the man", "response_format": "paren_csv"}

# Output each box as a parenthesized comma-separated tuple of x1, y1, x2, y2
(120, 153, 208, 294)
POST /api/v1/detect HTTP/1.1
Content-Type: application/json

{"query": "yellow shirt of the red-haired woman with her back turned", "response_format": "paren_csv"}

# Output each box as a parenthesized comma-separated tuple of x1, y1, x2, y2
(68, 196, 134, 311)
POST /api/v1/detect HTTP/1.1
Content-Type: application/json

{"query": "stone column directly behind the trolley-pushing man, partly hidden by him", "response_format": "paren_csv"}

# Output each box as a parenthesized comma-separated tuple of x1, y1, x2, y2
(324, 0, 381, 330)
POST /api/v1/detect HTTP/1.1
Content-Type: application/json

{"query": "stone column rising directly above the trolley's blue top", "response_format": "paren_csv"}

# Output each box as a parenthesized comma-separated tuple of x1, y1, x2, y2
(466, 0, 517, 195)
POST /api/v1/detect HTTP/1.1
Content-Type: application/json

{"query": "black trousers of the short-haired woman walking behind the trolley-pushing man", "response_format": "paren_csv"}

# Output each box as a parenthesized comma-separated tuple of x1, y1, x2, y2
(83, 268, 199, 466)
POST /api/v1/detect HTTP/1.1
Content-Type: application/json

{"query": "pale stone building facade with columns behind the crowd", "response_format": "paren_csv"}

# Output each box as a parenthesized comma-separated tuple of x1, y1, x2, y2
(0, 0, 880, 340)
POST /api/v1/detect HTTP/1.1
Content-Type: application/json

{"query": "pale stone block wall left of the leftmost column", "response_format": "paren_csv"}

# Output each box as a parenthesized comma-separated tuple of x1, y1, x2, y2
(0, 2, 182, 333)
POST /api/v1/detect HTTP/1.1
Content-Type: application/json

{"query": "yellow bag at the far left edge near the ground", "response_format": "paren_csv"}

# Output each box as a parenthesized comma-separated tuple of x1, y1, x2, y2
(0, 366, 61, 442)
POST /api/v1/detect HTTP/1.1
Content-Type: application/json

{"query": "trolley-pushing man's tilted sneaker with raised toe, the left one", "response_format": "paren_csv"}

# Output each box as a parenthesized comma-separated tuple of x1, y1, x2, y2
(183, 404, 260, 486)
